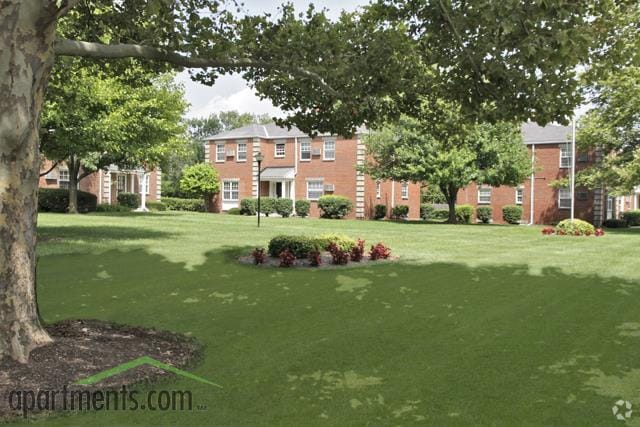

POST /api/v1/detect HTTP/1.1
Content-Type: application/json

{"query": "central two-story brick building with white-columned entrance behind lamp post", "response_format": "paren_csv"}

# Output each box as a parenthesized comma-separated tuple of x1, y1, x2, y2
(204, 124, 420, 219)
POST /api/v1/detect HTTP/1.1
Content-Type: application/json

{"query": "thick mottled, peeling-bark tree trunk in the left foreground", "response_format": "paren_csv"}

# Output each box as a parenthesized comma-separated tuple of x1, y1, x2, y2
(0, 0, 60, 363)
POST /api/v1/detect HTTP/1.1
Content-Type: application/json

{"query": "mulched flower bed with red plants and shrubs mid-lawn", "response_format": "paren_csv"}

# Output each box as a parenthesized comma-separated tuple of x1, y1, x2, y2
(240, 233, 396, 268)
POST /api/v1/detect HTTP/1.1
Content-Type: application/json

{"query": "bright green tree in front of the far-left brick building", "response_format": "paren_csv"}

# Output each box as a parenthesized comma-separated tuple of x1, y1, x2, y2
(40, 61, 187, 213)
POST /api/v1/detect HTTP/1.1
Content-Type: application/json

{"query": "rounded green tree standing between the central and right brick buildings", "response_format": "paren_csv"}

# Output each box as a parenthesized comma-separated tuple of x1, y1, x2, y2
(364, 100, 531, 223)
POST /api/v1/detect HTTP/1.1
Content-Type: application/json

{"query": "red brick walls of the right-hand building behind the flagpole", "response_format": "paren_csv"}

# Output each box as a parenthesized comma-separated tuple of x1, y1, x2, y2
(458, 144, 593, 224)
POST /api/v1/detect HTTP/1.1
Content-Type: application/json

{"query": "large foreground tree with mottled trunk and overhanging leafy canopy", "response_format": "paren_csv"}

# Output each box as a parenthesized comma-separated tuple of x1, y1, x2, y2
(0, 0, 636, 362)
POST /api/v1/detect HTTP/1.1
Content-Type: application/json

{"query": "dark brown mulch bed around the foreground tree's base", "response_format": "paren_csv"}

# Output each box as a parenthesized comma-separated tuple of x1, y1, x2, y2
(0, 320, 202, 421)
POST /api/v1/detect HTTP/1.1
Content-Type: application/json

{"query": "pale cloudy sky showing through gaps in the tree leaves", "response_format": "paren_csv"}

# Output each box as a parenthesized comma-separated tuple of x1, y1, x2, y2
(177, 0, 368, 117)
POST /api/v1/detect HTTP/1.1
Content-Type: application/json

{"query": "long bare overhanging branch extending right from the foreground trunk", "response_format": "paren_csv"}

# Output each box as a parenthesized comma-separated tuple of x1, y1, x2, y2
(54, 39, 340, 98)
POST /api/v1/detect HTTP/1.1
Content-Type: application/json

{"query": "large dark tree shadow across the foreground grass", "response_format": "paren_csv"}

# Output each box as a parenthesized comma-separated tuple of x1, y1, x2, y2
(33, 246, 640, 425)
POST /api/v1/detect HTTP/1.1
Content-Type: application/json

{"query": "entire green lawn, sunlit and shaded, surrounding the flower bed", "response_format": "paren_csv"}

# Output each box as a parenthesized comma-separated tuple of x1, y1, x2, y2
(27, 213, 640, 425)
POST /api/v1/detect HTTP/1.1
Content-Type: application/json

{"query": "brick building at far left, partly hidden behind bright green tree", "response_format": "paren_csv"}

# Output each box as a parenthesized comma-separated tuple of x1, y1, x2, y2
(39, 160, 162, 204)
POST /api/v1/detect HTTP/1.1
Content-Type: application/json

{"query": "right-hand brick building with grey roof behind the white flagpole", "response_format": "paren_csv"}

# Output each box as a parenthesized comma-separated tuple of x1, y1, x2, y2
(458, 123, 613, 224)
